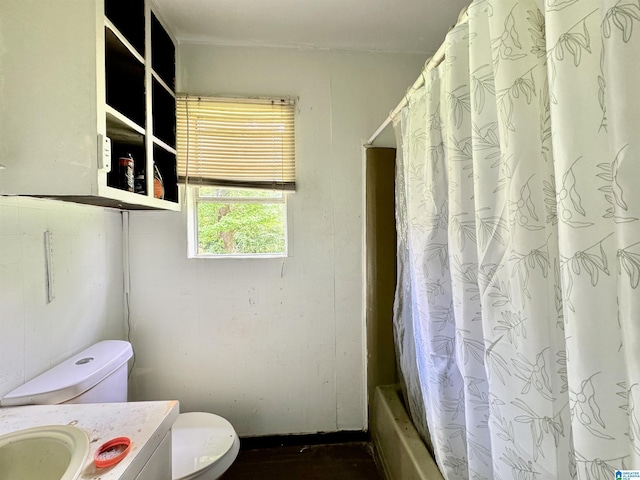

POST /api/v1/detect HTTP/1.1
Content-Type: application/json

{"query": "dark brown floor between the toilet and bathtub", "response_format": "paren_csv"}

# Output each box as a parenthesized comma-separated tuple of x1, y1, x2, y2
(220, 442, 382, 480)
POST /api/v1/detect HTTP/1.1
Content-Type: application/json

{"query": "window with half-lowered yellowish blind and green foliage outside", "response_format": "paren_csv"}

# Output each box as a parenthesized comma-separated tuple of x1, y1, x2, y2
(177, 96, 295, 257)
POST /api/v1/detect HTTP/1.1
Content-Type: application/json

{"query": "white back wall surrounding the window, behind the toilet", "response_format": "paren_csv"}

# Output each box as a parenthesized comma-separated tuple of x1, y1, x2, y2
(130, 44, 425, 435)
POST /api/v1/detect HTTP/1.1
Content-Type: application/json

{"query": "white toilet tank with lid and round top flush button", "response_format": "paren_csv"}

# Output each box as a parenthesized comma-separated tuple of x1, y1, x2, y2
(0, 340, 133, 407)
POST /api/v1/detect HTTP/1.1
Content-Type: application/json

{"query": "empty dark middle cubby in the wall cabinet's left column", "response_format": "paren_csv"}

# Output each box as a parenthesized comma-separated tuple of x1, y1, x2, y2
(105, 28, 145, 128)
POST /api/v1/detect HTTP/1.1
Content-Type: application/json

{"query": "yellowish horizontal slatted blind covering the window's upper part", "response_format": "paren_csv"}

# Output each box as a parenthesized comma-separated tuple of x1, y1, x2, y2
(176, 95, 295, 190)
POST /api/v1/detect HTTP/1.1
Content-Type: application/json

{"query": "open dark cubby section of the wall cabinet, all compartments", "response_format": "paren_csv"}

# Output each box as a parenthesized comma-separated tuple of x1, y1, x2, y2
(105, 0, 178, 203)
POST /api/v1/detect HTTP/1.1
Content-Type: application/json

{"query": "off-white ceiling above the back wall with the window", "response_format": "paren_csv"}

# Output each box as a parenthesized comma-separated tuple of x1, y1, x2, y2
(155, 0, 469, 54)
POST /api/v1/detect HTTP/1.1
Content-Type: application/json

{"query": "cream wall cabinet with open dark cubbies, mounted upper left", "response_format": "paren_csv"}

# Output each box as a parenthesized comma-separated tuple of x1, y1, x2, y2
(0, 0, 180, 210)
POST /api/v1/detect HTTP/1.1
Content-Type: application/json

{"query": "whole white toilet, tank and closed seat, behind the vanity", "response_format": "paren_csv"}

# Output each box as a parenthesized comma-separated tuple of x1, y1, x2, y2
(0, 340, 240, 480)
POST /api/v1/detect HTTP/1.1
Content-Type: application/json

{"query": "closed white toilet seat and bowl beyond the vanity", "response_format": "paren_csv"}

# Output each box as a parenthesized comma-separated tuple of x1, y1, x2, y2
(171, 412, 240, 480)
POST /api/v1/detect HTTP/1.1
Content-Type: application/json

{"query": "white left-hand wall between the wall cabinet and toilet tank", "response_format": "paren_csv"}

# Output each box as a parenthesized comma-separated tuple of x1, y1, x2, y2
(0, 195, 125, 396)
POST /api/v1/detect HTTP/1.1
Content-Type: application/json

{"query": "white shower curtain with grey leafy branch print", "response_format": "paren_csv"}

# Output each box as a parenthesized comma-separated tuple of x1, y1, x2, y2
(394, 0, 640, 480)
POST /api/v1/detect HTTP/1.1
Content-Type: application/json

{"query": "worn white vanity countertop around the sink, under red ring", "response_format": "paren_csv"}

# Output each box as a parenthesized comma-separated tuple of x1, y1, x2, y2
(0, 400, 179, 480)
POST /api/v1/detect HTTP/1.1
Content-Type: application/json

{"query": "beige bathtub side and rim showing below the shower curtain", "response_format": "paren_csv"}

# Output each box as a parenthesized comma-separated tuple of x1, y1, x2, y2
(370, 385, 444, 480)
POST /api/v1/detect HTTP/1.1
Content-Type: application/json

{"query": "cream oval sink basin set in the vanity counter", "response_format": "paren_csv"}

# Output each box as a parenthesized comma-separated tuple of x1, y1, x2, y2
(0, 425, 89, 480)
